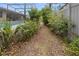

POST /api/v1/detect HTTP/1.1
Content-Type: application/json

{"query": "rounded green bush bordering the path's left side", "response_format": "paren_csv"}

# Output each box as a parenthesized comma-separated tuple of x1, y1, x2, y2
(15, 20, 38, 41)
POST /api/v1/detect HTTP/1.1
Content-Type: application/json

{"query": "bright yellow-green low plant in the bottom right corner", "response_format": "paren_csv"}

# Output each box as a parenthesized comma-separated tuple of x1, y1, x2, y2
(66, 37, 79, 56)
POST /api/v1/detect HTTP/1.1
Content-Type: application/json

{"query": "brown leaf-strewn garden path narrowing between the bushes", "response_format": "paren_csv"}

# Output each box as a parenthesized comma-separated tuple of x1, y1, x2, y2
(5, 26, 66, 56)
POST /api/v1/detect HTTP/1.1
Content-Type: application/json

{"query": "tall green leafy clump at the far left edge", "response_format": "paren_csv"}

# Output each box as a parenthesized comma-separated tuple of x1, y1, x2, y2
(0, 21, 13, 55)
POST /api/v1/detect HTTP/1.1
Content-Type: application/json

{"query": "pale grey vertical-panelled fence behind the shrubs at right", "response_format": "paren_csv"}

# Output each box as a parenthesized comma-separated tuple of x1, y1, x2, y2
(59, 3, 79, 39)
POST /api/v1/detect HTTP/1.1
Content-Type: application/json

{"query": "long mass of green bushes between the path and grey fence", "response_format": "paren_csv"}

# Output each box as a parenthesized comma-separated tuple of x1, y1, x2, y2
(41, 7, 72, 36)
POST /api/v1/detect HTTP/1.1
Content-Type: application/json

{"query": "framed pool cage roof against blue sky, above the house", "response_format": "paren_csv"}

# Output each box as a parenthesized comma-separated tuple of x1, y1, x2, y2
(0, 3, 39, 18)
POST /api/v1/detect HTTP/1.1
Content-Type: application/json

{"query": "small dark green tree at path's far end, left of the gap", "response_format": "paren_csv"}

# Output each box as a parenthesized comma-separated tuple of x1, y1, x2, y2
(28, 8, 41, 21)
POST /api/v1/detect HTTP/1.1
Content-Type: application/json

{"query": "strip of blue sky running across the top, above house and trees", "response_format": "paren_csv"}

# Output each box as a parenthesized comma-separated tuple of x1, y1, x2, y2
(0, 3, 65, 17)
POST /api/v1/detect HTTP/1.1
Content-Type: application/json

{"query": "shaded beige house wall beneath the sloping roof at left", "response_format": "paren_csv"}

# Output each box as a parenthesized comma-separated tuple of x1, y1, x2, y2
(0, 10, 24, 21)
